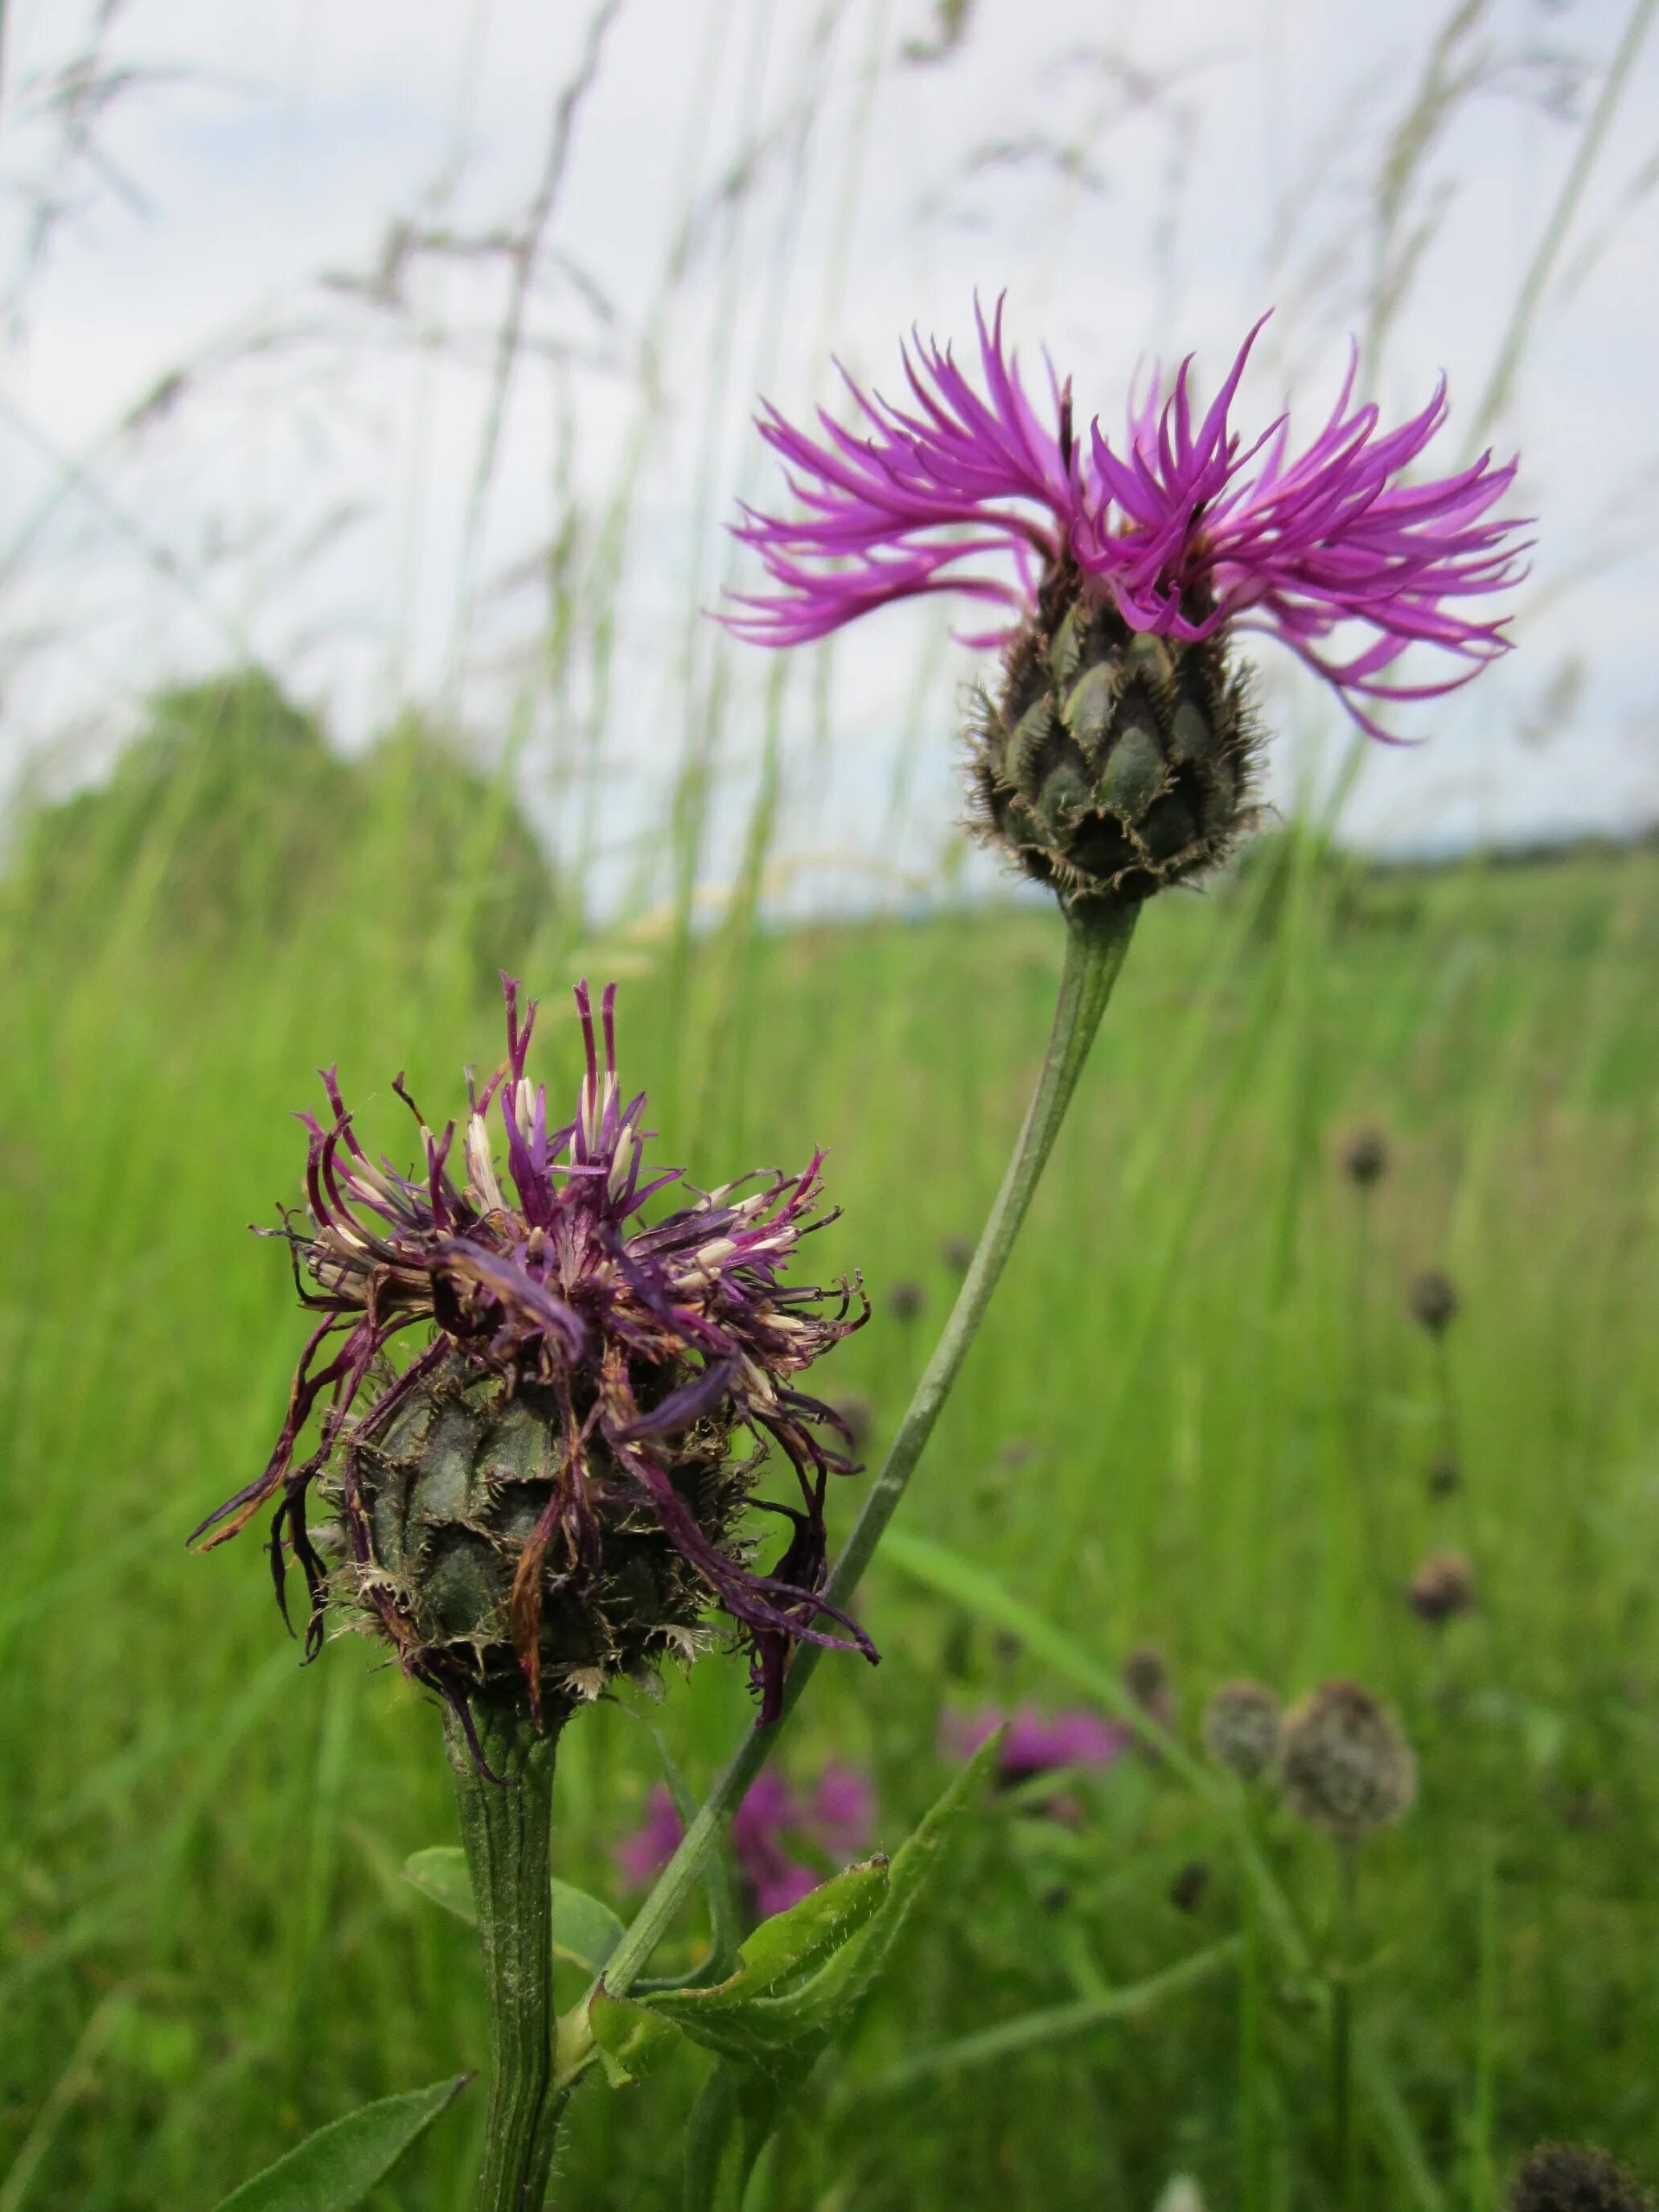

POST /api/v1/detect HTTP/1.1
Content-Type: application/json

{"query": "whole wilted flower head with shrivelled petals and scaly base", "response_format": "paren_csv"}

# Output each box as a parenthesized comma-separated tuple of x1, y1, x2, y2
(197, 978, 876, 1770)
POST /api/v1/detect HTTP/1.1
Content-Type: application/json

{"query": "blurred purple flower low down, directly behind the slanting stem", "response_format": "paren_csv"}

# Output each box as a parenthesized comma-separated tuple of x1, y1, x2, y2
(615, 1766, 876, 1920)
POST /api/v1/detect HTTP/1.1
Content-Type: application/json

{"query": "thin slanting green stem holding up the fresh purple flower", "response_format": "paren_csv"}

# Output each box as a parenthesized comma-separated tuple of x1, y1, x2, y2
(604, 907, 1135, 1997)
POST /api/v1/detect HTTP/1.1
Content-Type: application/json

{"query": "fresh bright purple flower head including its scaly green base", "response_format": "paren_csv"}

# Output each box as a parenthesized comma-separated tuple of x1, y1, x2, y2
(728, 303, 1524, 907)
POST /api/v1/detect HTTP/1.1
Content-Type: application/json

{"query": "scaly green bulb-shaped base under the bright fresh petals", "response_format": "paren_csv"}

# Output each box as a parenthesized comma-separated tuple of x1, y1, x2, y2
(969, 562, 1256, 909)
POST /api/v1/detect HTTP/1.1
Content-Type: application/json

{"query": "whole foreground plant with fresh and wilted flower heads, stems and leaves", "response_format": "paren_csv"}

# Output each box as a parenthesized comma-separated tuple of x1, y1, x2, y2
(199, 310, 1521, 2212)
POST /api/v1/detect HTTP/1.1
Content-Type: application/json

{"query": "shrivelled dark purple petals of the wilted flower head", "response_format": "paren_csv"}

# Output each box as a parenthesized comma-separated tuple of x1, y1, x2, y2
(195, 978, 874, 1719)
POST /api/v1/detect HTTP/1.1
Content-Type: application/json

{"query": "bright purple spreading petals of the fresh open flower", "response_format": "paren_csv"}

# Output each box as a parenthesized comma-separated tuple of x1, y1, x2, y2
(725, 303, 1524, 737)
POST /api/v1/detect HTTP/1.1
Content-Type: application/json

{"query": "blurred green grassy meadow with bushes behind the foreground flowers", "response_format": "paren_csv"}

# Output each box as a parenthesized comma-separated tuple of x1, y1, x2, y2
(0, 681, 1659, 2212)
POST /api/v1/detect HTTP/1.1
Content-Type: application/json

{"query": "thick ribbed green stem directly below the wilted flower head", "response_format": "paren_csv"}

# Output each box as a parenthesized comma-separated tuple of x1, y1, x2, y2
(445, 1708, 564, 2212)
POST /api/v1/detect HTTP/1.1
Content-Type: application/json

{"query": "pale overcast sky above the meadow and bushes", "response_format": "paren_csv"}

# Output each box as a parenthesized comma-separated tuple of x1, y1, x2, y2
(0, 0, 1659, 898)
